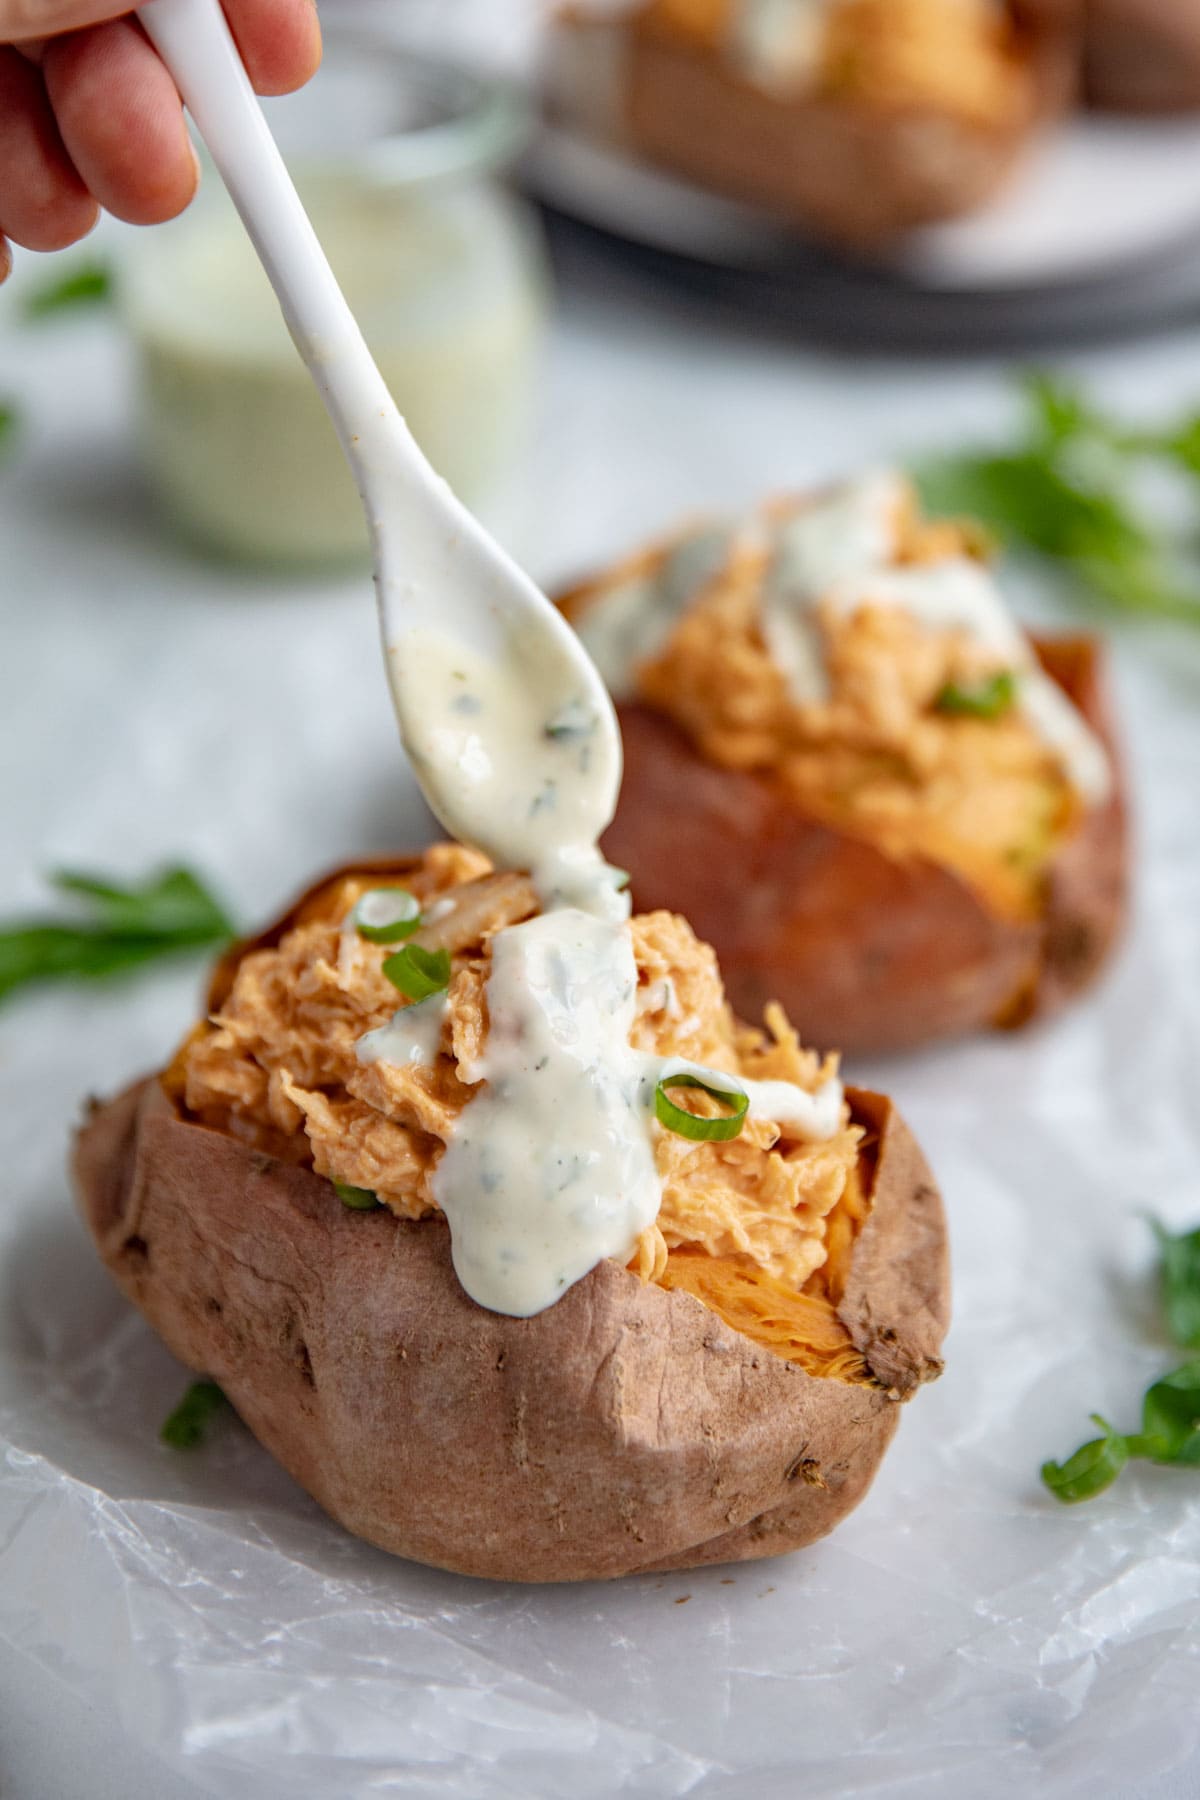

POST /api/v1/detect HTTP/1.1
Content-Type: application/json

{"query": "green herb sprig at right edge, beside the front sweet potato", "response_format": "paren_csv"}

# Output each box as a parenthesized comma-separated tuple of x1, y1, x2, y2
(1042, 1220, 1200, 1505)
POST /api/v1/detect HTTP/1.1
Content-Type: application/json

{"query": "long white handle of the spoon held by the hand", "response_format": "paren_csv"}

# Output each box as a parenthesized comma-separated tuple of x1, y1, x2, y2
(139, 0, 437, 526)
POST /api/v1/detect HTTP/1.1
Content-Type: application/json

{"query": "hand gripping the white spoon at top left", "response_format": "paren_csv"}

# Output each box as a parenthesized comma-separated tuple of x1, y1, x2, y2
(0, 0, 320, 281)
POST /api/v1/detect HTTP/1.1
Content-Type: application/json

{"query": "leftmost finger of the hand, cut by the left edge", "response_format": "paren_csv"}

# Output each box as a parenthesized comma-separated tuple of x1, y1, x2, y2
(0, 49, 97, 252)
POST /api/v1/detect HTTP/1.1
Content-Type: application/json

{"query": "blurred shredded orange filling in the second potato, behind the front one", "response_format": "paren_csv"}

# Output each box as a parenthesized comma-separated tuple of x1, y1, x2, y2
(569, 493, 1081, 922)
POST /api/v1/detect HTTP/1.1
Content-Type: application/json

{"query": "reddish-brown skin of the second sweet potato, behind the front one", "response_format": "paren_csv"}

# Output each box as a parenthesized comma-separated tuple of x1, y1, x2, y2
(604, 637, 1128, 1053)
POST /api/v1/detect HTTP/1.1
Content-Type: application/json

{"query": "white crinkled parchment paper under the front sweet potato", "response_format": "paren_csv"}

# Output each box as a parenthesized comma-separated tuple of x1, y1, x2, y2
(0, 640, 1200, 1800)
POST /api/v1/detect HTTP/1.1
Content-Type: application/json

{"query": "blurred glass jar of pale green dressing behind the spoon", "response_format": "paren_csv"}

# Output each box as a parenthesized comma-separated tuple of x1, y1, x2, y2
(121, 38, 549, 565)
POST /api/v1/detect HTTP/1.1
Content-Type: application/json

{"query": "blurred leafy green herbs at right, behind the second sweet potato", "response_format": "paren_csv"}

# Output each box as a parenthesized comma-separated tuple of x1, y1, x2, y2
(916, 374, 1200, 625)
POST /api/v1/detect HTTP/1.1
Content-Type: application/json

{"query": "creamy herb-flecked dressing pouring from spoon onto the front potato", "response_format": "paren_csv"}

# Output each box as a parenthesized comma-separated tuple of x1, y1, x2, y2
(367, 597, 842, 1318)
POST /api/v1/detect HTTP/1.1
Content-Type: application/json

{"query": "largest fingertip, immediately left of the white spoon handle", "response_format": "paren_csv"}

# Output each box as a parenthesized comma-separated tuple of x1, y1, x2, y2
(41, 20, 200, 225)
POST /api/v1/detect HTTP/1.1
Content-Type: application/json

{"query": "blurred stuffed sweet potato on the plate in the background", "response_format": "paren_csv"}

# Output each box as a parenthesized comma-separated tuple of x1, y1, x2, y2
(547, 0, 1078, 245)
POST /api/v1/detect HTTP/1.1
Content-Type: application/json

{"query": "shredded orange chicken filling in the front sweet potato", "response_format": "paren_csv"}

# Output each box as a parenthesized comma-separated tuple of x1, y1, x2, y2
(166, 844, 865, 1379)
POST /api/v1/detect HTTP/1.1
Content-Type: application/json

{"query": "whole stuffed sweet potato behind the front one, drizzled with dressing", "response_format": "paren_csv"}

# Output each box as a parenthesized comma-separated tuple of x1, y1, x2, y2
(560, 472, 1128, 1053)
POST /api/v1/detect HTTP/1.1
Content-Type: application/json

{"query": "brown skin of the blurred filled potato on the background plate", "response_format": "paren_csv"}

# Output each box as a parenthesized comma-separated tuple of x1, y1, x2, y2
(558, 0, 1078, 247)
